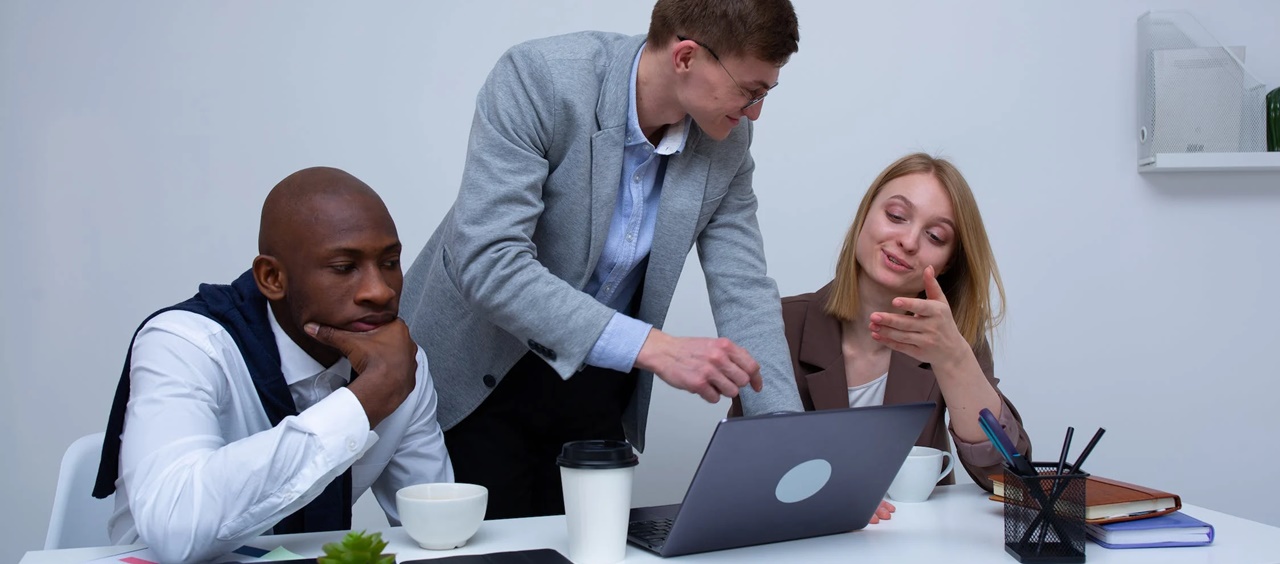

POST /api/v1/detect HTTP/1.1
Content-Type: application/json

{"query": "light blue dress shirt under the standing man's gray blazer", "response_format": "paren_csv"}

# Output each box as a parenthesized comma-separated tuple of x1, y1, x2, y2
(582, 46, 689, 372)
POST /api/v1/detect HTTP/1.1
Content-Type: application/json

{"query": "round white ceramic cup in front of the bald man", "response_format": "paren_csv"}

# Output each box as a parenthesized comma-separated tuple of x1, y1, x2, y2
(396, 483, 489, 550)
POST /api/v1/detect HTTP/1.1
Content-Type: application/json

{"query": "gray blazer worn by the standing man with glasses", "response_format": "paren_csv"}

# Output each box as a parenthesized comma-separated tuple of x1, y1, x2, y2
(401, 32, 803, 449)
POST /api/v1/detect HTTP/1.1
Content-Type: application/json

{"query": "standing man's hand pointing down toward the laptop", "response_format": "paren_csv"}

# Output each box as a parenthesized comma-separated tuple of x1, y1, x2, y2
(635, 329, 764, 403)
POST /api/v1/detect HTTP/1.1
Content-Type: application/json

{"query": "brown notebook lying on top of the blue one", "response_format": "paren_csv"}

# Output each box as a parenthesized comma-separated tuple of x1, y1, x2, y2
(991, 474, 1183, 524)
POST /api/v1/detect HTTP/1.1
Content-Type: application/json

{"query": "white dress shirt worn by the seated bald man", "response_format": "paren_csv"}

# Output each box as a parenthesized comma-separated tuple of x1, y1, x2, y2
(108, 311, 453, 561)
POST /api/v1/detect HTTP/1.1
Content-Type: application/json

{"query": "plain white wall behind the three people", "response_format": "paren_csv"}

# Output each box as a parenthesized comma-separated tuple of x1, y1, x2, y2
(0, 0, 1280, 561)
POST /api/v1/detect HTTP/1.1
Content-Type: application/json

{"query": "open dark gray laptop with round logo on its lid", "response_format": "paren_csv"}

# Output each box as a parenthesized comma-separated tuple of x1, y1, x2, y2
(627, 402, 934, 556)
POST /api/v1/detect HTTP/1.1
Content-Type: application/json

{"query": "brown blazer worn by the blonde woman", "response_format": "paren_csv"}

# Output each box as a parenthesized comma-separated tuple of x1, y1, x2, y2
(730, 284, 1032, 491)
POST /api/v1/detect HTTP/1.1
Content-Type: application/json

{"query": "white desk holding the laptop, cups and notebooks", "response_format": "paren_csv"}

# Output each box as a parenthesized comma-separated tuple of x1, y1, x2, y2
(22, 485, 1280, 564)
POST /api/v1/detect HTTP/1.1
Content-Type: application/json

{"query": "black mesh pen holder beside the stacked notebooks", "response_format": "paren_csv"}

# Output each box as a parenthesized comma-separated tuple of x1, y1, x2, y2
(1004, 463, 1089, 563)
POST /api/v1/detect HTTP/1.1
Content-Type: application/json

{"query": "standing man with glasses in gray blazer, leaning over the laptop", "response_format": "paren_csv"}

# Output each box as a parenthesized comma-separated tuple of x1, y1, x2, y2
(402, 0, 803, 518)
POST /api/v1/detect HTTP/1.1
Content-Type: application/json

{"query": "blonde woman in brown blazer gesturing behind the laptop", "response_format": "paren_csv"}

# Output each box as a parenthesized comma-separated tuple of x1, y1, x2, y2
(731, 153, 1032, 496)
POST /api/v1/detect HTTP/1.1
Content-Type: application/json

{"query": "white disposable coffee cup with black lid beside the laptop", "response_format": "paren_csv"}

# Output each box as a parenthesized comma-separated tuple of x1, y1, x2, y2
(556, 440, 640, 564)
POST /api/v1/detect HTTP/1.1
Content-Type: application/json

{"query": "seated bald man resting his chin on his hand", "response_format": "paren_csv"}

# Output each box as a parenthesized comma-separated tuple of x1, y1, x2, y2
(93, 168, 453, 561)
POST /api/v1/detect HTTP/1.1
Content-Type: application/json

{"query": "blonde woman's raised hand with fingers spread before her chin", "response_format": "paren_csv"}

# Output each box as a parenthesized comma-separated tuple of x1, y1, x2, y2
(869, 266, 973, 364)
